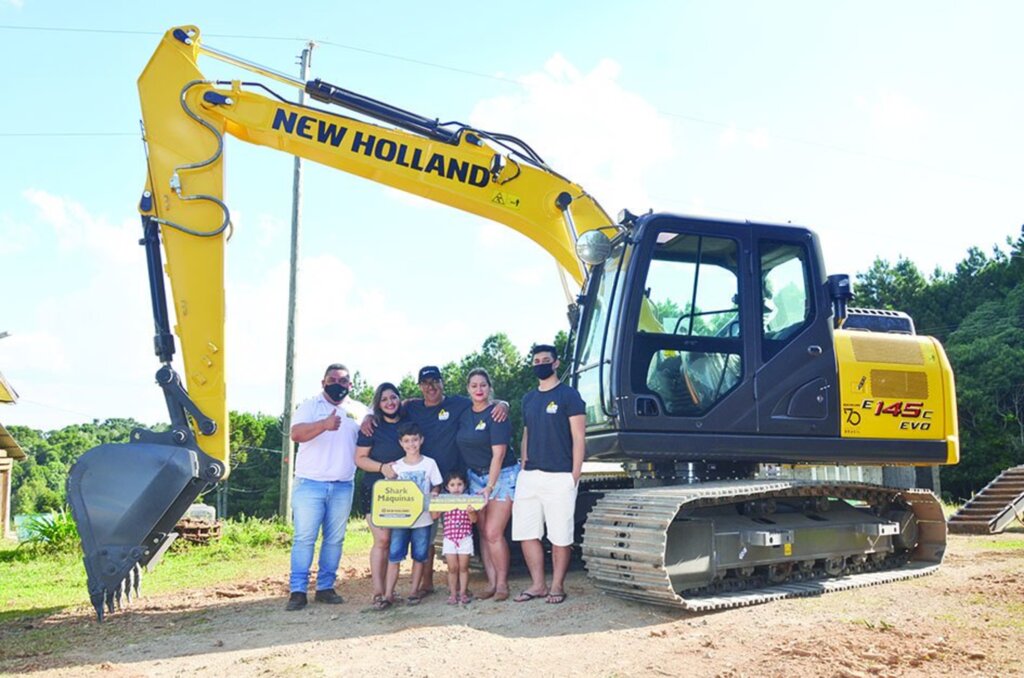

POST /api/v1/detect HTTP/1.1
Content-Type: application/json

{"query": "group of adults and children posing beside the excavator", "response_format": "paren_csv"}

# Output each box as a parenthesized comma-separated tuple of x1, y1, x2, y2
(287, 344, 585, 610)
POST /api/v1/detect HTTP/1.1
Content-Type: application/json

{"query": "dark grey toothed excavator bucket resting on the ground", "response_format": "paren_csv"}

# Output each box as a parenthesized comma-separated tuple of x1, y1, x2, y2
(68, 442, 223, 621)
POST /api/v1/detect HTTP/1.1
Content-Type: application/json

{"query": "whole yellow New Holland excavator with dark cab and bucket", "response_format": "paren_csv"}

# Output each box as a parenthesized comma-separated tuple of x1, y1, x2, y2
(68, 26, 958, 619)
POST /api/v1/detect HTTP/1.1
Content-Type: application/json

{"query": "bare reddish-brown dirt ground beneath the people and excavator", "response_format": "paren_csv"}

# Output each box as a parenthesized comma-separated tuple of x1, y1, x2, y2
(0, 532, 1024, 678)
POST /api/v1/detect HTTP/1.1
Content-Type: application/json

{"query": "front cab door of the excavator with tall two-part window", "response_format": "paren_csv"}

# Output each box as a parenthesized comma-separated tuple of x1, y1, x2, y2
(615, 215, 758, 433)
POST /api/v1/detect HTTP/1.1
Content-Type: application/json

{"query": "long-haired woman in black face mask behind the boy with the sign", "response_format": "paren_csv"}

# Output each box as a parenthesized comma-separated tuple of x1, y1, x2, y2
(355, 382, 406, 603)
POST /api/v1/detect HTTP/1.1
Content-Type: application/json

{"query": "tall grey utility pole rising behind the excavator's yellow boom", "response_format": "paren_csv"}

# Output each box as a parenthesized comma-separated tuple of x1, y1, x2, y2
(278, 40, 315, 522)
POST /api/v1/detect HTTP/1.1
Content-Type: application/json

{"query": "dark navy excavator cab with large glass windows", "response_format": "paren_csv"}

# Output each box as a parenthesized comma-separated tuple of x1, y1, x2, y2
(573, 214, 947, 479)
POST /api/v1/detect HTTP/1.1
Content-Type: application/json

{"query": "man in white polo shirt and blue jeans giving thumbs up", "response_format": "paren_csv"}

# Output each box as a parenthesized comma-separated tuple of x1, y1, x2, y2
(286, 364, 367, 610)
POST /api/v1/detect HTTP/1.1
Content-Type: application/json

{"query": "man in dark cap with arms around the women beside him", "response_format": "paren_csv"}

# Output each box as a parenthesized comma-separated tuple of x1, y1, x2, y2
(362, 365, 509, 592)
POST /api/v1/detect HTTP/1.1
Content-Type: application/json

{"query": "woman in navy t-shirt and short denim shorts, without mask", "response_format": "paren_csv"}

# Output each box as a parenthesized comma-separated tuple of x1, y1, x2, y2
(456, 368, 519, 600)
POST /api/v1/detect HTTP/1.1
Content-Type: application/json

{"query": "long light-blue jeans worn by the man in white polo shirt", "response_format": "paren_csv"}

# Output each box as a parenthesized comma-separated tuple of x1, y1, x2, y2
(289, 478, 352, 593)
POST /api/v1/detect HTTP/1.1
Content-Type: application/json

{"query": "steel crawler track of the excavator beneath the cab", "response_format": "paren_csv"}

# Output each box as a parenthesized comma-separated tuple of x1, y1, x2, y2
(583, 480, 946, 611)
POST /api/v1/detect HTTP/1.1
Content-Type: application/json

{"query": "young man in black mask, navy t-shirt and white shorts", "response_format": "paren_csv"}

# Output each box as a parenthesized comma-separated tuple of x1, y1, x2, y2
(512, 344, 587, 603)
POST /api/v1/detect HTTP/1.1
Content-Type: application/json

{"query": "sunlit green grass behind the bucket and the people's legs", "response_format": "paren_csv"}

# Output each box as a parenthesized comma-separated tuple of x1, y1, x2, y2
(0, 518, 373, 625)
